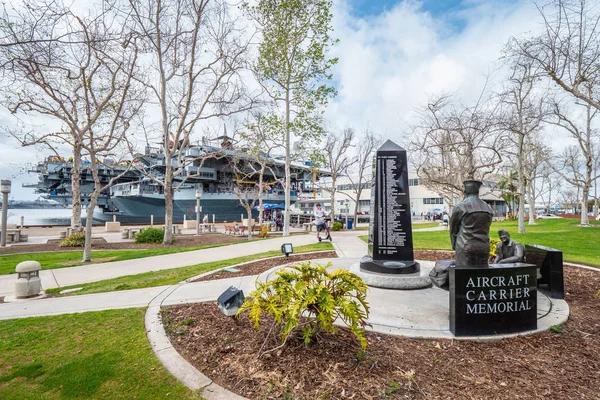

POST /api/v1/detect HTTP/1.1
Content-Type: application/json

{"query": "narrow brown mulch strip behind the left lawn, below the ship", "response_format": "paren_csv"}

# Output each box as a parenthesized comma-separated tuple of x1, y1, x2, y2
(0, 233, 248, 255)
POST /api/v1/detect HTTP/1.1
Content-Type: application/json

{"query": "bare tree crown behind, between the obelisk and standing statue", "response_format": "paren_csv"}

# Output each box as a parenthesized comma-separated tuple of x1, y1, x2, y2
(411, 92, 502, 208)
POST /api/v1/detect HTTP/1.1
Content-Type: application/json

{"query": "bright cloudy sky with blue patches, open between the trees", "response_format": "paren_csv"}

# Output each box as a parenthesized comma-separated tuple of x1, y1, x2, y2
(0, 0, 560, 199)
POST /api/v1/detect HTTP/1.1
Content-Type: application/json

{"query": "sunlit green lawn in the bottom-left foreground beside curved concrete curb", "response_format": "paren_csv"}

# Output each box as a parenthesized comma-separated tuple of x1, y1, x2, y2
(0, 308, 199, 400)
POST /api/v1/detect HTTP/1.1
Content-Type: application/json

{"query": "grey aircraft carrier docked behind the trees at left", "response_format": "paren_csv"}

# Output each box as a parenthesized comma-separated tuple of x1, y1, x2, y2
(24, 138, 327, 222)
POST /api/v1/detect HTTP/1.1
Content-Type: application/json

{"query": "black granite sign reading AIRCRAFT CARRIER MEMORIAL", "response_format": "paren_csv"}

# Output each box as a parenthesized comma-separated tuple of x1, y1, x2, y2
(450, 263, 537, 336)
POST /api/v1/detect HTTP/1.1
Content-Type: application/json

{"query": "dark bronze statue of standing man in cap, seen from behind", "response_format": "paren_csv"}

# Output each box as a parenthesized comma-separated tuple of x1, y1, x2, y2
(450, 181, 494, 267)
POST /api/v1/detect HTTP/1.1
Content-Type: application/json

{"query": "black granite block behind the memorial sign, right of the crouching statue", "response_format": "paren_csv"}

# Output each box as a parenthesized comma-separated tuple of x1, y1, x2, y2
(525, 244, 565, 299)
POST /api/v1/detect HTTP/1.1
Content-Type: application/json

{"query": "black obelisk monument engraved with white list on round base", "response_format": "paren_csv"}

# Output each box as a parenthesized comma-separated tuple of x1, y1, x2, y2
(360, 140, 420, 274)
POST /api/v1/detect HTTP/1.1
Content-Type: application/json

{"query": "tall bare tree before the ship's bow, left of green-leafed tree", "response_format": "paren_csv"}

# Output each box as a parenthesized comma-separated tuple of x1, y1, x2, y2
(128, 0, 253, 243)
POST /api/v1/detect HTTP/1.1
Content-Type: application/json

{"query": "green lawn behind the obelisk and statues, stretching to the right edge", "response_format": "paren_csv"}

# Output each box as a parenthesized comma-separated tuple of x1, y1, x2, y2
(360, 218, 600, 266)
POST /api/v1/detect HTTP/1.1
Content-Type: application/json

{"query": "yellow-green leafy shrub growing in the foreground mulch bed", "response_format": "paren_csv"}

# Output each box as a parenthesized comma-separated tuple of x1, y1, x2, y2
(238, 262, 369, 349)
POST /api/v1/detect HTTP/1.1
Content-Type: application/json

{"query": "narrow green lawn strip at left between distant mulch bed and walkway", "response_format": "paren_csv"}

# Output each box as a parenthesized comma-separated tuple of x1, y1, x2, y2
(0, 242, 238, 275)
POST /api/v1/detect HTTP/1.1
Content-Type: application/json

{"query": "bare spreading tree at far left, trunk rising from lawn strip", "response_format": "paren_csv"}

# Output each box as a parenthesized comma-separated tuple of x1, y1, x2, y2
(0, 2, 143, 262)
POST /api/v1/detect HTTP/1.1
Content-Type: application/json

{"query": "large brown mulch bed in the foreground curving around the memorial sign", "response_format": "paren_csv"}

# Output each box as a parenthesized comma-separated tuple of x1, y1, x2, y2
(163, 266, 600, 399)
